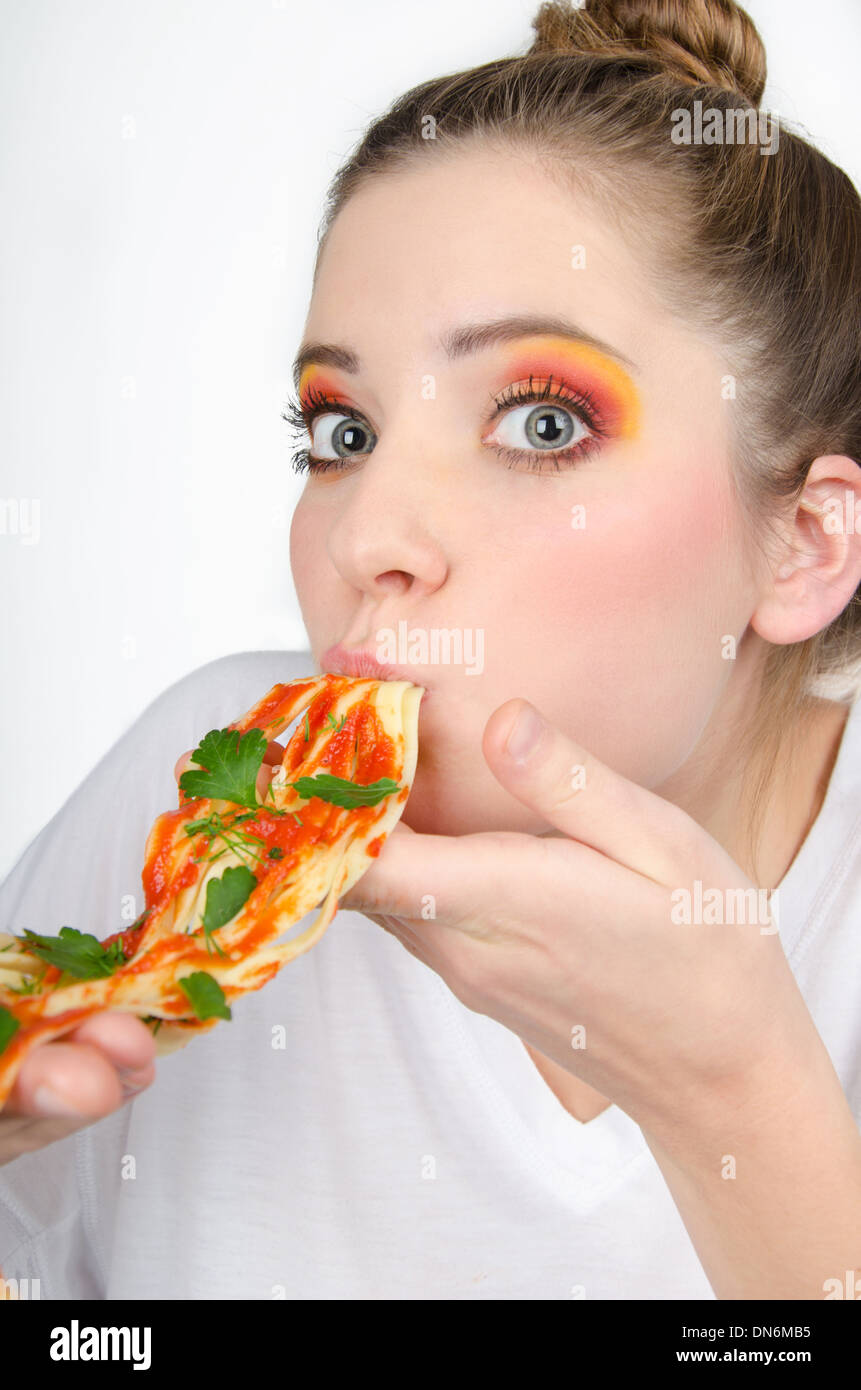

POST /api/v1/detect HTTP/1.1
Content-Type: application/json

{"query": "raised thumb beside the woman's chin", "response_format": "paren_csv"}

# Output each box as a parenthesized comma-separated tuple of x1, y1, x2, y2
(481, 699, 704, 884)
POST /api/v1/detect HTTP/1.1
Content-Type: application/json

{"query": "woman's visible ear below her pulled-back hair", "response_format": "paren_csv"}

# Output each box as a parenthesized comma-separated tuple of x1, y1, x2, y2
(751, 453, 861, 645)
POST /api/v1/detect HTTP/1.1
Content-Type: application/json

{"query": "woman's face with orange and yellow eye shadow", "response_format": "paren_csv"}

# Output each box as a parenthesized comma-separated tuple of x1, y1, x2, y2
(291, 150, 758, 834)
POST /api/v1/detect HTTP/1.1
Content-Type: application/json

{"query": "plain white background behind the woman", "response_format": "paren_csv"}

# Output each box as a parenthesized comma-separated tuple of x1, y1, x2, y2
(0, 0, 861, 878)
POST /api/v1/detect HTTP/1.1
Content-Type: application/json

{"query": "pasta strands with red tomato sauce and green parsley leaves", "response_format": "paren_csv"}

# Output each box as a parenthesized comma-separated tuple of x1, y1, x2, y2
(0, 674, 423, 1108)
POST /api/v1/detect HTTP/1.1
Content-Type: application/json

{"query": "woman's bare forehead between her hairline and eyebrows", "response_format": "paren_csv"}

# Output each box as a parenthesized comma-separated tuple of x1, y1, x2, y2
(303, 149, 666, 360)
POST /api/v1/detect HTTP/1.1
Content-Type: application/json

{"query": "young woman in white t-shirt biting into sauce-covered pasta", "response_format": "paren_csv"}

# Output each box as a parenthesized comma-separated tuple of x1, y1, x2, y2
(0, 0, 861, 1300)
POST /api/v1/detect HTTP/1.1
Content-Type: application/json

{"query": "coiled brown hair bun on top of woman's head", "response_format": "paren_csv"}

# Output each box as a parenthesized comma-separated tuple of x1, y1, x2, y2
(529, 0, 765, 106)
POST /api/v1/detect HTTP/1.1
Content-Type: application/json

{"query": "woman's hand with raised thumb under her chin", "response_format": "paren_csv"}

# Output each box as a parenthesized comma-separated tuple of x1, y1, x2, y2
(341, 699, 812, 1127)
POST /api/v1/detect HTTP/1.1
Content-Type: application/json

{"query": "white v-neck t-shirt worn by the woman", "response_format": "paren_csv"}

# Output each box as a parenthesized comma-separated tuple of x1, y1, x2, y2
(0, 652, 861, 1300)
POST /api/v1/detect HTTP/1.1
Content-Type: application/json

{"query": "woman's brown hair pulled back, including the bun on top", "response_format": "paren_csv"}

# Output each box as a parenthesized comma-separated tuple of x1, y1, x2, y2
(314, 0, 861, 872)
